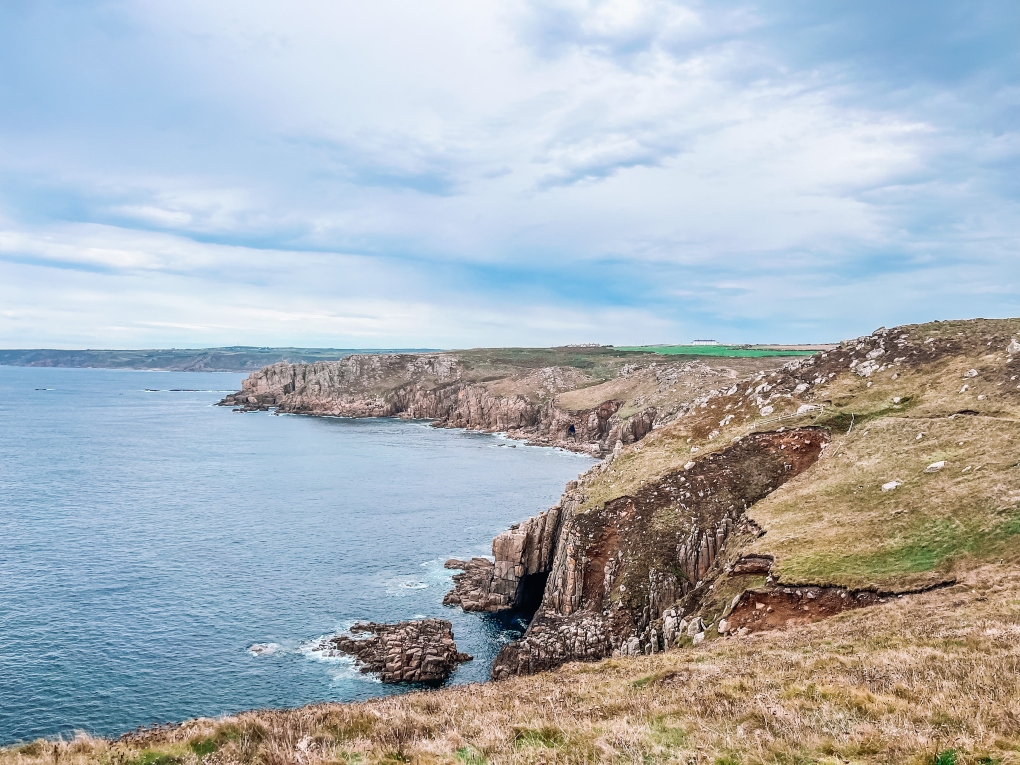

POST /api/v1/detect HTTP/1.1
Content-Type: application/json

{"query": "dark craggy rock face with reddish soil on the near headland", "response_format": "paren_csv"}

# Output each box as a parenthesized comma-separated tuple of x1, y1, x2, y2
(469, 428, 828, 679)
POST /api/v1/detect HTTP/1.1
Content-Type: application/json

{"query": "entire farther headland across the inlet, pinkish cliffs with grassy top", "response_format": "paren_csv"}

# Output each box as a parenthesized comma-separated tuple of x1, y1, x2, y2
(220, 349, 779, 455)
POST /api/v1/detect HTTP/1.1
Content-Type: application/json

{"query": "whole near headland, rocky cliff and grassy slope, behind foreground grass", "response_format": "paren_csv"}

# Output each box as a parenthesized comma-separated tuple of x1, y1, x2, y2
(447, 321, 1020, 679)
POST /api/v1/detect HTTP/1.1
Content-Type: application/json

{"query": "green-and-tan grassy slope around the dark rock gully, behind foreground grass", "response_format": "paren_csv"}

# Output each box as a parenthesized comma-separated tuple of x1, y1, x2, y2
(587, 320, 1020, 591)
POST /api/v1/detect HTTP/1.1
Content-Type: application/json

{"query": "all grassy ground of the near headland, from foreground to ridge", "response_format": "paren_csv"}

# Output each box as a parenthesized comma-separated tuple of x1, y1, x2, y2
(7, 319, 1020, 765)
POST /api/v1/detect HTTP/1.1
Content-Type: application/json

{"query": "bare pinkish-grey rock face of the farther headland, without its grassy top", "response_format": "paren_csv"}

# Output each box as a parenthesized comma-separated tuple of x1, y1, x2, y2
(220, 354, 656, 454)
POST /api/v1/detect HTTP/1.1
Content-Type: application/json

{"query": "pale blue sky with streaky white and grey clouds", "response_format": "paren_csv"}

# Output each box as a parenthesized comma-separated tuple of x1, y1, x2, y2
(0, 0, 1020, 348)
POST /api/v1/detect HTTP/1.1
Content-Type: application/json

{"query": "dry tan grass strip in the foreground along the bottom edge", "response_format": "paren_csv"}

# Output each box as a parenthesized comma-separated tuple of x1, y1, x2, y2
(7, 566, 1020, 765)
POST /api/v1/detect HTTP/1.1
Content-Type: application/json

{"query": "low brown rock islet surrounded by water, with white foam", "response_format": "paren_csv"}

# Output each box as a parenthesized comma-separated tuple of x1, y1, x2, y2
(323, 619, 472, 682)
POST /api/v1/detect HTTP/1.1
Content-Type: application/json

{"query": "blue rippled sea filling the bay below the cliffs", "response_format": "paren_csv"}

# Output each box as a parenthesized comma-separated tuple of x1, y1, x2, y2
(0, 366, 591, 744)
